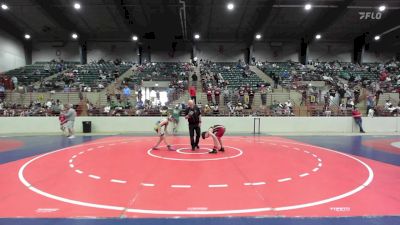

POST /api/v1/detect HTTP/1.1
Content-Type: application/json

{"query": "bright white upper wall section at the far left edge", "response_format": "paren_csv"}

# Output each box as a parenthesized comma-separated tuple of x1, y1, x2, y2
(0, 30, 25, 72)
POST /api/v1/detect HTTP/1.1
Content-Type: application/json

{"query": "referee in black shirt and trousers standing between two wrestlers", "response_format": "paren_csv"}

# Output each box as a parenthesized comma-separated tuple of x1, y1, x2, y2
(185, 100, 201, 151)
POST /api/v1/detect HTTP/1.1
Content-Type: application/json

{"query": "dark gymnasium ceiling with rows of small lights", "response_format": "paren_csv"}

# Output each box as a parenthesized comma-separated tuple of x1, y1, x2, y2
(0, 0, 400, 46)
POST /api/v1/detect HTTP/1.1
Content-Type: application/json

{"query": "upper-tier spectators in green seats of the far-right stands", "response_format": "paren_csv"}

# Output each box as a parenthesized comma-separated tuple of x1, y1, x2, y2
(256, 60, 400, 92)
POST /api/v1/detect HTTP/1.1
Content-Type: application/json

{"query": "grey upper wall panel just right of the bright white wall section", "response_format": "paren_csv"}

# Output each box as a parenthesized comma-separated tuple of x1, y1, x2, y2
(32, 41, 80, 63)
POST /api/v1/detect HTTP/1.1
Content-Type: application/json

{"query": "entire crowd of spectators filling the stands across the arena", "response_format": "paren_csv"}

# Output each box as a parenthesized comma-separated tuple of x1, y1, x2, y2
(0, 57, 400, 116)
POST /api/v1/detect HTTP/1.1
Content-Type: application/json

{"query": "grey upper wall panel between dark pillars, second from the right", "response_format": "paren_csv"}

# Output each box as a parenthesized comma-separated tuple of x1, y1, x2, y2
(308, 41, 353, 62)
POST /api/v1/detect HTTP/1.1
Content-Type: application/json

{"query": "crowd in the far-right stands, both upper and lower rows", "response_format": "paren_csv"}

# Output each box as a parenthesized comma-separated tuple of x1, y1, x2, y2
(257, 60, 400, 115)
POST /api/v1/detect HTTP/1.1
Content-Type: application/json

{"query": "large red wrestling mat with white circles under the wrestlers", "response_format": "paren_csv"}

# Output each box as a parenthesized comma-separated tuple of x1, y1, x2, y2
(0, 137, 400, 217)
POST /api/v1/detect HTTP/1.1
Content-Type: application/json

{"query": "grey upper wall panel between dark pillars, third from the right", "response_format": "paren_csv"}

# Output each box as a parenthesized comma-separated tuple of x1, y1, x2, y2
(253, 42, 300, 62)
